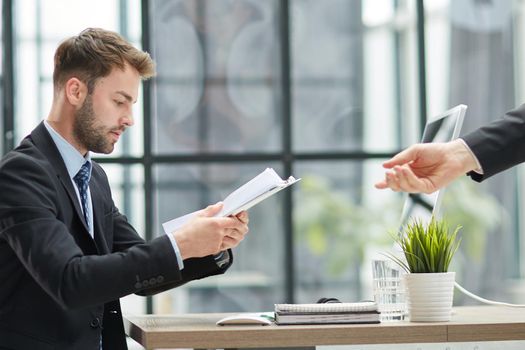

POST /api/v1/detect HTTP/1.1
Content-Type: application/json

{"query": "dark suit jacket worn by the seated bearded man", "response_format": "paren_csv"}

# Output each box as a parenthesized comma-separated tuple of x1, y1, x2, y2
(0, 123, 232, 350)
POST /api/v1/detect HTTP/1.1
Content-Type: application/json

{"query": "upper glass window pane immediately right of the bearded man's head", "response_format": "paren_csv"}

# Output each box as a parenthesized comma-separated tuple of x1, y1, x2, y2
(150, 0, 281, 154)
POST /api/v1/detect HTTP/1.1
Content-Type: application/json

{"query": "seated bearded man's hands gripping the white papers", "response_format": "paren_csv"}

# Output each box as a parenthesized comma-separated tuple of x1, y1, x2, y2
(173, 203, 249, 260)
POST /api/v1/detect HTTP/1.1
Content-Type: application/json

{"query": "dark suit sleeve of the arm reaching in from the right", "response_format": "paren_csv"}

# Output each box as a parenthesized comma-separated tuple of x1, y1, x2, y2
(461, 104, 525, 181)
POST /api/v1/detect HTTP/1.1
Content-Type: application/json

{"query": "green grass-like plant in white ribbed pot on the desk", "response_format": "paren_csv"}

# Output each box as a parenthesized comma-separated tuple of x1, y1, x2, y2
(391, 217, 461, 322)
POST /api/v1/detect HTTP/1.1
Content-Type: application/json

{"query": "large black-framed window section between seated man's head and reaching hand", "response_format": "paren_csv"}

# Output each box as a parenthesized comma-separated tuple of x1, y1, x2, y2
(148, 0, 419, 312)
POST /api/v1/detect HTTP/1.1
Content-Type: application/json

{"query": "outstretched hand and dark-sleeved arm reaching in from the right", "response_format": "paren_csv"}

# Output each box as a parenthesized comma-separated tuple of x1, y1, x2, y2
(376, 104, 525, 193)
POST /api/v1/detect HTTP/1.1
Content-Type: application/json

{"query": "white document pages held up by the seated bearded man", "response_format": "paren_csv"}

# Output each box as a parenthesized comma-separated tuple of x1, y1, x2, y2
(162, 168, 300, 233)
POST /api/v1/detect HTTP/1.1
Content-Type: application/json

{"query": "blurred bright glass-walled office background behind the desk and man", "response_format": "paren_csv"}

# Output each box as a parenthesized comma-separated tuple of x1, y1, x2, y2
(0, 0, 525, 349)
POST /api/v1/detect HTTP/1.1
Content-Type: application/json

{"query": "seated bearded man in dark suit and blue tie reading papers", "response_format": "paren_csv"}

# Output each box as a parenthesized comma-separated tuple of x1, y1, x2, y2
(0, 29, 248, 350)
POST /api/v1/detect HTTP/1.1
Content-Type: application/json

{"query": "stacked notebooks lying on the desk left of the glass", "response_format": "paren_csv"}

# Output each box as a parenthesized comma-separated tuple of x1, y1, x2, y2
(275, 301, 379, 325)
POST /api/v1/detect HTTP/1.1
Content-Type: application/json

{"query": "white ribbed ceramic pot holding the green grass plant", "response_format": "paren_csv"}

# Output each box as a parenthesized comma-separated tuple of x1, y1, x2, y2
(405, 272, 456, 322)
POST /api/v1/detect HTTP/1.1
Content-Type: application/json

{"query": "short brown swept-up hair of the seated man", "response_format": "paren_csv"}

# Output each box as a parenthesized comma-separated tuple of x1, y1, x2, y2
(53, 28, 155, 93)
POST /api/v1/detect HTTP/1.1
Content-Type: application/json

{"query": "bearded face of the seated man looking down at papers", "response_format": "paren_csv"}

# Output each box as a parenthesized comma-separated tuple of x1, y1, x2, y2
(73, 65, 140, 154)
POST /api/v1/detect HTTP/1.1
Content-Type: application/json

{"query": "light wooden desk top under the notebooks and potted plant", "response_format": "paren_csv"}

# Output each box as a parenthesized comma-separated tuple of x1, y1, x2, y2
(125, 306, 525, 349)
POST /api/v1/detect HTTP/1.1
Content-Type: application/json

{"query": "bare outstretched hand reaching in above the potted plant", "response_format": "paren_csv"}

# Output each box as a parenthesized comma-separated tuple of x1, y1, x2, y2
(375, 140, 477, 193)
